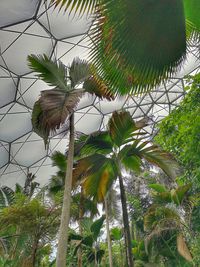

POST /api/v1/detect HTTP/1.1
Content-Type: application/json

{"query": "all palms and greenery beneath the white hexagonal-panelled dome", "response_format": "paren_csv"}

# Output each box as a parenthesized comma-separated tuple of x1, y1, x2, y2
(0, 0, 200, 267)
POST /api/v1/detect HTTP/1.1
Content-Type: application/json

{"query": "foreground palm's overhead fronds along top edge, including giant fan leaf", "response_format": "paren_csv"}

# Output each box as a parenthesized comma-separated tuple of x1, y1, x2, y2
(51, 0, 200, 94)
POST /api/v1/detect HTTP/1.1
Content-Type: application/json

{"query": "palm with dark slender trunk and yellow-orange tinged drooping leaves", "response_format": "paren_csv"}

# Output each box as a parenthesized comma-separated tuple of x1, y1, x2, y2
(73, 111, 176, 267)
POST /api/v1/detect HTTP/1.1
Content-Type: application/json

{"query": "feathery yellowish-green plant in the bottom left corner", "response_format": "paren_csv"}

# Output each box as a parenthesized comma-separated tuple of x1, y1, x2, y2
(0, 188, 60, 267)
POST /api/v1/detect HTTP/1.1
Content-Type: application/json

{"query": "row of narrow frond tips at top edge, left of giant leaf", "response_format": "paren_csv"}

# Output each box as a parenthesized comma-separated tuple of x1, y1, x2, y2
(51, 0, 100, 15)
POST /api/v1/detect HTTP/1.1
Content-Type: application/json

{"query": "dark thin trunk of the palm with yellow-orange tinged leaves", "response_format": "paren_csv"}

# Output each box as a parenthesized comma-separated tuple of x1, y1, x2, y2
(119, 173, 133, 267)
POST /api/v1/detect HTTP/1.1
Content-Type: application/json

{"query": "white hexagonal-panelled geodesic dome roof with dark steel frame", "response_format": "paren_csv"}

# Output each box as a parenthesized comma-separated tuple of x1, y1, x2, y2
(0, 0, 200, 186)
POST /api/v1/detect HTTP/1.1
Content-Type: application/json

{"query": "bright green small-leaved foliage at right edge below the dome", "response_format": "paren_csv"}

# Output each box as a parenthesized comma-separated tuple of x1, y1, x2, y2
(155, 74, 200, 188)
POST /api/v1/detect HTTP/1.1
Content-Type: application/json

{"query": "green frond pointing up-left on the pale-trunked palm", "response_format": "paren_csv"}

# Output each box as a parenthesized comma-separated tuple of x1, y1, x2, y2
(28, 55, 69, 91)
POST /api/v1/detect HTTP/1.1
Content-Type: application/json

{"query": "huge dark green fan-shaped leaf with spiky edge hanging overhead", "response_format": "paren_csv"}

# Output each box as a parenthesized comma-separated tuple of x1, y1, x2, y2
(92, 0, 186, 92)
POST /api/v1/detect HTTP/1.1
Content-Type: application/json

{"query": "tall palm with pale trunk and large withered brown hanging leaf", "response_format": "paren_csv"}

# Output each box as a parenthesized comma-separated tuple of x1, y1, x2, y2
(28, 55, 113, 267)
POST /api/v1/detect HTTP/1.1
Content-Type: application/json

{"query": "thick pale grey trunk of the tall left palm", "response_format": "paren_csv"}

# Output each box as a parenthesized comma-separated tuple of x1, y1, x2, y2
(56, 114, 74, 267)
